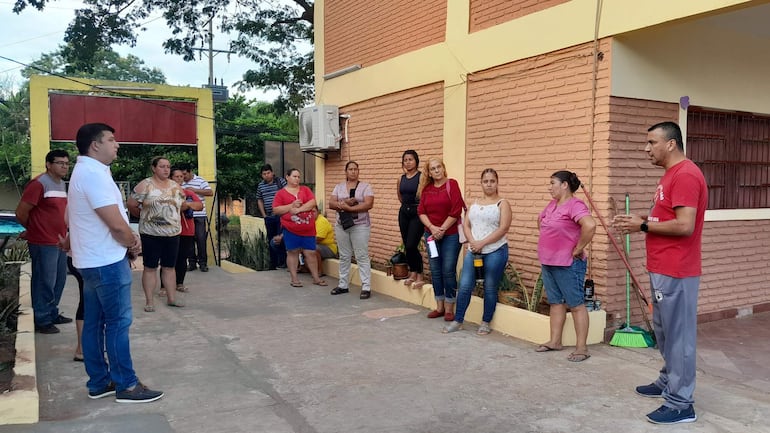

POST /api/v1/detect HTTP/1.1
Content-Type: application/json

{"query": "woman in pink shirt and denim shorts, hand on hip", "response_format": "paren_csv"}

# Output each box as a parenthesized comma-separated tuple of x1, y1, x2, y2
(537, 170, 596, 362)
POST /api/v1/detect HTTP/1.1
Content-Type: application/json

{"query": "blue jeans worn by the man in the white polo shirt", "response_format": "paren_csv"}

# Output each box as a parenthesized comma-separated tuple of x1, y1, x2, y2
(80, 258, 138, 391)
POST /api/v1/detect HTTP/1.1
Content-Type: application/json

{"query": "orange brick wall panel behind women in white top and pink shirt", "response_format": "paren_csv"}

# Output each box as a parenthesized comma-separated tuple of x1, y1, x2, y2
(465, 41, 610, 293)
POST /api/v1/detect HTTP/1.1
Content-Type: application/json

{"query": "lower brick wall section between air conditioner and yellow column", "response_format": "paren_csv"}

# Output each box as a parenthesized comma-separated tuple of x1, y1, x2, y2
(324, 83, 444, 264)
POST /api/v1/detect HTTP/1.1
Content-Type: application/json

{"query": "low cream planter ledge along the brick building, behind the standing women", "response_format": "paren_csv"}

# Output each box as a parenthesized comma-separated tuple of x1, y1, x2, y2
(323, 259, 607, 346)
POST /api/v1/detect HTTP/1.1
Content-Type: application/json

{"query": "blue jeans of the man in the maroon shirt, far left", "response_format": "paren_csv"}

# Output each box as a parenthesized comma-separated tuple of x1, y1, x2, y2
(29, 244, 67, 327)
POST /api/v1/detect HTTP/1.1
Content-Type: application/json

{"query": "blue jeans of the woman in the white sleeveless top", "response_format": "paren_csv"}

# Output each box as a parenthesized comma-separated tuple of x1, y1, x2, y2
(455, 244, 508, 323)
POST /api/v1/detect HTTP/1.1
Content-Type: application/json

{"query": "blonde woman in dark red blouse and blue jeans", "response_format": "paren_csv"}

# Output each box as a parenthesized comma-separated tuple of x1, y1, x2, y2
(417, 158, 465, 322)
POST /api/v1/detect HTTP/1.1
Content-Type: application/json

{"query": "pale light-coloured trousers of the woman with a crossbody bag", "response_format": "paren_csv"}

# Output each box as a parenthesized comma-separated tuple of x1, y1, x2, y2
(334, 224, 372, 291)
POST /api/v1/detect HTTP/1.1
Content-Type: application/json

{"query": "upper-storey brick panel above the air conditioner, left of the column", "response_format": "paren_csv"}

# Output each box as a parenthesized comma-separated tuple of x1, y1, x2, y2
(324, 0, 447, 74)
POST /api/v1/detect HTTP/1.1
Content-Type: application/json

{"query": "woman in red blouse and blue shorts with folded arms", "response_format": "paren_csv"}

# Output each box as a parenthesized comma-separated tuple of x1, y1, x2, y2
(273, 168, 327, 287)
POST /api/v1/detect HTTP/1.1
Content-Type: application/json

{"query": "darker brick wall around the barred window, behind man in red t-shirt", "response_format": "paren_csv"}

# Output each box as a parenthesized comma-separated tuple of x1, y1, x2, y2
(602, 97, 770, 327)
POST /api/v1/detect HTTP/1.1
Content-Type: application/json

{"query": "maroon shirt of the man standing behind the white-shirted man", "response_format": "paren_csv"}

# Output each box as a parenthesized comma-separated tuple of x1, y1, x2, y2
(21, 173, 67, 245)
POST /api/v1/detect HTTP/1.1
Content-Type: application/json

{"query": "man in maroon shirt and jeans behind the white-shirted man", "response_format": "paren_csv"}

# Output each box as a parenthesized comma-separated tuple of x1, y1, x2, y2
(16, 149, 72, 334)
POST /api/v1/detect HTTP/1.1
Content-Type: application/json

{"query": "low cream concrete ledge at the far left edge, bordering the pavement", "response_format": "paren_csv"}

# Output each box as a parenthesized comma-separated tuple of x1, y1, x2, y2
(0, 263, 40, 424)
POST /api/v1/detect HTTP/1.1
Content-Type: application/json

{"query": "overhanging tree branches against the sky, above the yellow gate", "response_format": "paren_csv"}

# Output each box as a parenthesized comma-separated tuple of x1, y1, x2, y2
(13, 0, 314, 110)
